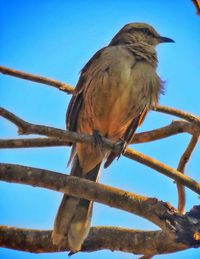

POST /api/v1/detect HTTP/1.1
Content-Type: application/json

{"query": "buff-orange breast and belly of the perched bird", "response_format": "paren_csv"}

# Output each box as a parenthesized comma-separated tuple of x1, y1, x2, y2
(76, 46, 159, 140)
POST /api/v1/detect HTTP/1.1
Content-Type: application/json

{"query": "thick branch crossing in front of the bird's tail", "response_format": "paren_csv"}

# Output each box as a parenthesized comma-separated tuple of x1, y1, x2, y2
(0, 163, 180, 228)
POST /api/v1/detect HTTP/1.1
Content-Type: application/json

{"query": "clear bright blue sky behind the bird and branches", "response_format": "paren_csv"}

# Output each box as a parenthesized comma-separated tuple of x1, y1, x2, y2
(0, 0, 200, 259)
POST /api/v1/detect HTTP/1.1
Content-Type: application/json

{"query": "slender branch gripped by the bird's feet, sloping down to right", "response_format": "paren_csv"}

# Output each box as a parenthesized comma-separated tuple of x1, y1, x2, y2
(0, 108, 200, 194)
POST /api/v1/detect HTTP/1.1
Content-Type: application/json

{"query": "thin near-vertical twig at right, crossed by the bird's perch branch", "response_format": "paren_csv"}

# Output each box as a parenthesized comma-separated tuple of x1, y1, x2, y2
(177, 133, 199, 213)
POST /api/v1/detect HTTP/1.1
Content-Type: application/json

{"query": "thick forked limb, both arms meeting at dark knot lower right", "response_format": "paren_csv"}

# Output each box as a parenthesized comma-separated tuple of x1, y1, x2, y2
(0, 164, 200, 255)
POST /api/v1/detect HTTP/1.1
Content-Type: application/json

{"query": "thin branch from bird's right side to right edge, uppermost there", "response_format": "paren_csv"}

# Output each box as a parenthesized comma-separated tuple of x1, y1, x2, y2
(153, 105, 200, 130)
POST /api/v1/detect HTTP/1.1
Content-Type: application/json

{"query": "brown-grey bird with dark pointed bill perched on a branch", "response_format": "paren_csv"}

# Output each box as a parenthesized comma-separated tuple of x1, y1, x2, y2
(52, 22, 174, 253)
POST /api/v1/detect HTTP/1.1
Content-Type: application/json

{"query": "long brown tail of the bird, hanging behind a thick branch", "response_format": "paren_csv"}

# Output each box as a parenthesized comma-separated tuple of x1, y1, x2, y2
(52, 155, 101, 252)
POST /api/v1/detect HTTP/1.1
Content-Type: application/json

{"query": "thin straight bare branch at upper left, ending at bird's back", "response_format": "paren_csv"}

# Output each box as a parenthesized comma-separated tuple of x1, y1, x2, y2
(0, 66, 74, 94)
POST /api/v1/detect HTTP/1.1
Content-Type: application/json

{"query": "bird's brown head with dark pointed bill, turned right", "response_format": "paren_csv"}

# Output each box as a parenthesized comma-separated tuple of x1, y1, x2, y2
(110, 23, 174, 46)
